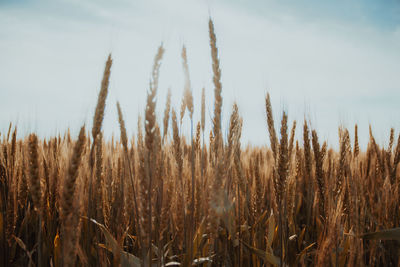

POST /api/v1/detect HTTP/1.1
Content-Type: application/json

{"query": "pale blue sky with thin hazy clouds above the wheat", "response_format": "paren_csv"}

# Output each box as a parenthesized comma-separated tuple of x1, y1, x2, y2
(0, 0, 400, 147)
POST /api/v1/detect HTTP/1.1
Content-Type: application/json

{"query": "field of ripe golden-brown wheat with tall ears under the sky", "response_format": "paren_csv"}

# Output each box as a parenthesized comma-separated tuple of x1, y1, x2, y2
(0, 19, 400, 266)
